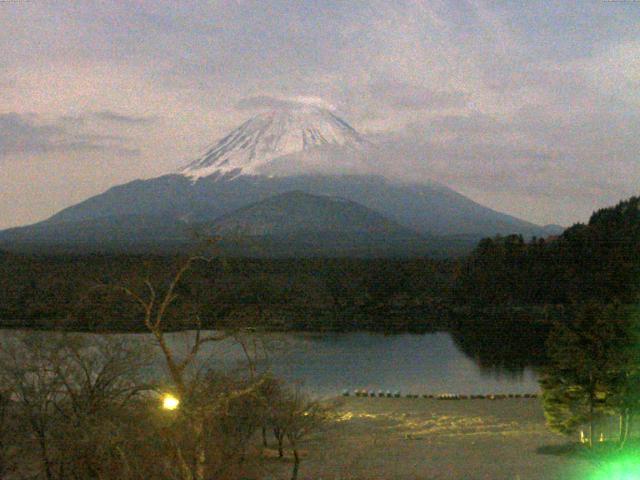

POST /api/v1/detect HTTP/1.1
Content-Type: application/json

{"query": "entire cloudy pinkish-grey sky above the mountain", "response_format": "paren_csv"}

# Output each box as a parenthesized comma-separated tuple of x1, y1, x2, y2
(0, 0, 640, 228)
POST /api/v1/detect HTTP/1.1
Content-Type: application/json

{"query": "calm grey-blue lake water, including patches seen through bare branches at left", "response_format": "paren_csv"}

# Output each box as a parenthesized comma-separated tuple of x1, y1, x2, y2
(0, 331, 538, 395)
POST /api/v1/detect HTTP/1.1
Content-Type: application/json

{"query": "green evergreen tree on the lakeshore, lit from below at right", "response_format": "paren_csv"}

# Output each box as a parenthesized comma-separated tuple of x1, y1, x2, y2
(540, 304, 638, 446)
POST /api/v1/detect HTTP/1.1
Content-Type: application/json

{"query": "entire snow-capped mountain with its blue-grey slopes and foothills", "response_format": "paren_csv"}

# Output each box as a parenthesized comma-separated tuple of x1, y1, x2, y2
(0, 106, 557, 255)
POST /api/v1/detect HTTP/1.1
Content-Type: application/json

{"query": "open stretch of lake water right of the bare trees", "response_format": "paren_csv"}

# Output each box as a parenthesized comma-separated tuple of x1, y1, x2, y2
(242, 333, 538, 394)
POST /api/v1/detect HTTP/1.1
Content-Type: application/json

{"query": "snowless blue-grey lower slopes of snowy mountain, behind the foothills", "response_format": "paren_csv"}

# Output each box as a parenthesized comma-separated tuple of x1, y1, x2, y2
(35, 175, 544, 238)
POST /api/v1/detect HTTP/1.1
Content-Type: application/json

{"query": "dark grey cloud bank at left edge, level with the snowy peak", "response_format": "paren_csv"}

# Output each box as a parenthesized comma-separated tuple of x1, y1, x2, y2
(0, 112, 139, 158)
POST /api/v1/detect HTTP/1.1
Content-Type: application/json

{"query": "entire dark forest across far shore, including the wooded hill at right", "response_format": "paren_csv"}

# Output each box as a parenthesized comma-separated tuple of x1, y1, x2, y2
(0, 197, 640, 364)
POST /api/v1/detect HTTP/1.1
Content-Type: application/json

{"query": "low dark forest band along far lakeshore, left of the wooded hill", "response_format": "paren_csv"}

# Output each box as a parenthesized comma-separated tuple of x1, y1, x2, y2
(0, 254, 453, 331)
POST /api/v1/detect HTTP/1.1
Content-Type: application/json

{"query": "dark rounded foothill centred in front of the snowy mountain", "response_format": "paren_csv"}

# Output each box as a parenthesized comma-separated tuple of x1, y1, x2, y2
(207, 191, 432, 257)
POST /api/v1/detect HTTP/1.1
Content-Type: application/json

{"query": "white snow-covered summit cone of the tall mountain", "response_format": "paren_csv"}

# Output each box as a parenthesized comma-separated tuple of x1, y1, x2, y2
(179, 105, 366, 179)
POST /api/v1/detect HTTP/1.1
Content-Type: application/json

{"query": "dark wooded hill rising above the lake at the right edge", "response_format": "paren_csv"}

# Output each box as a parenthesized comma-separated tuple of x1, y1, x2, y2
(455, 197, 640, 305)
